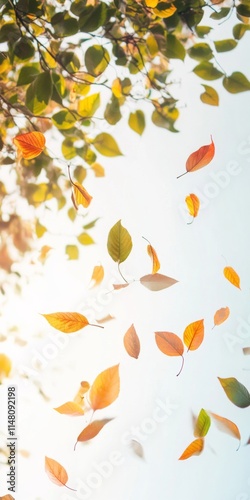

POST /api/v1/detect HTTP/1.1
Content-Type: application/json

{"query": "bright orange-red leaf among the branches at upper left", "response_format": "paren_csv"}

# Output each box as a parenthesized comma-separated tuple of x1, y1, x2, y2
(13, 132, 45, 160)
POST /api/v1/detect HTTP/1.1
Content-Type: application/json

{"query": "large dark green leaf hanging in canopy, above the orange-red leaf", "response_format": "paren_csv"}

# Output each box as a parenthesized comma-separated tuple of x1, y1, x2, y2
(25, 71, 52, 115)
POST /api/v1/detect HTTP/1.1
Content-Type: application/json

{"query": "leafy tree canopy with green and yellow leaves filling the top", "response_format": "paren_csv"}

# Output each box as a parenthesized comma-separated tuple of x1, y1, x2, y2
(0, 0, 250, 291)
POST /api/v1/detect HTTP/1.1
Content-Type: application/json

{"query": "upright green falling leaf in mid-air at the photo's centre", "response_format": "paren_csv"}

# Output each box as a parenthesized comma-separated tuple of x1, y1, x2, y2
(107, 220, 133, 264)
